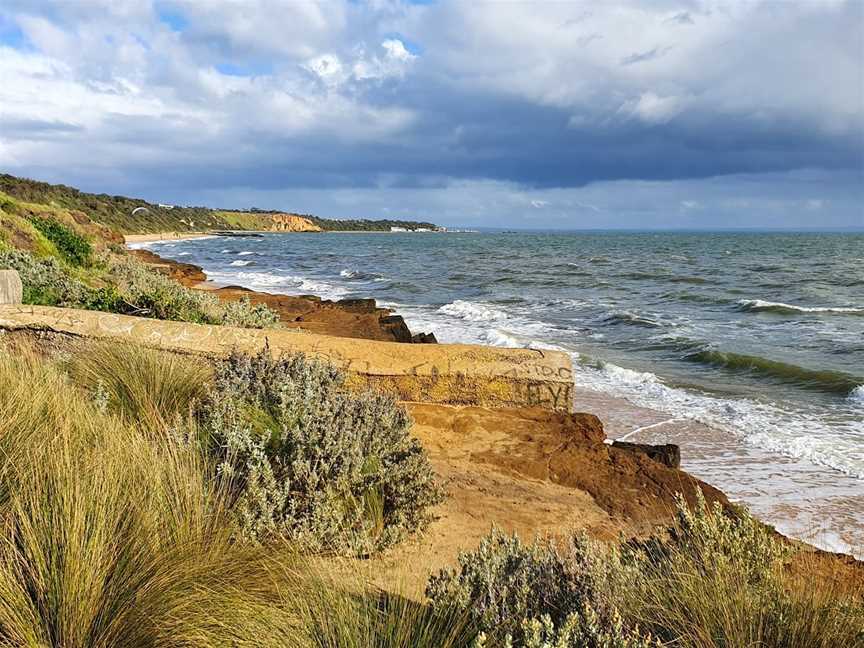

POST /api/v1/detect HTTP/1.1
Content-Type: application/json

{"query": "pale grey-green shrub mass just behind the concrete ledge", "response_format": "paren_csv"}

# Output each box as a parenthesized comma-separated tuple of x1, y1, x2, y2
(106, 255, 279, 328)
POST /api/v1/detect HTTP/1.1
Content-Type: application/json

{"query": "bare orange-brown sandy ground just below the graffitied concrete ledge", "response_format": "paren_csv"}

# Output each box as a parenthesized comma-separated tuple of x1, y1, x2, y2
(382, 403, 728, 591)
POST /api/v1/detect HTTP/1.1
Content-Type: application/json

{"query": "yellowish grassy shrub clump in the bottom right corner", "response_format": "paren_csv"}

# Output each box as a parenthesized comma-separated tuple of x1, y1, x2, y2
(626, 497, 864, 648)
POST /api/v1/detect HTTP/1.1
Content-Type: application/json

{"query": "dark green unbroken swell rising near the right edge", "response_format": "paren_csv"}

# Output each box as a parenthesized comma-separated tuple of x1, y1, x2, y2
(684, 349, 864, 396)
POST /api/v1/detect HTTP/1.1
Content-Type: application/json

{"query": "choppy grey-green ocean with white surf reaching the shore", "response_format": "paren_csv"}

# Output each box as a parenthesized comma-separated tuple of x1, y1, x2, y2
(132, 232, 864, 557)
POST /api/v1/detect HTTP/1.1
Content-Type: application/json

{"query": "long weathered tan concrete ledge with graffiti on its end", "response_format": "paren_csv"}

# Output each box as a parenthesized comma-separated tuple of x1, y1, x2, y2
(0, 305, 573, 411)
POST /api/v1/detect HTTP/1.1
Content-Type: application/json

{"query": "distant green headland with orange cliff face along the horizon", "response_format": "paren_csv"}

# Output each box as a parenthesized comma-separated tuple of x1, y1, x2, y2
(0, 174, 437, 234)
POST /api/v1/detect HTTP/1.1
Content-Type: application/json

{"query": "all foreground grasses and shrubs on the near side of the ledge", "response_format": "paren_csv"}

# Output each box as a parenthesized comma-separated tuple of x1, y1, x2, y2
(0, 338, 864, 648)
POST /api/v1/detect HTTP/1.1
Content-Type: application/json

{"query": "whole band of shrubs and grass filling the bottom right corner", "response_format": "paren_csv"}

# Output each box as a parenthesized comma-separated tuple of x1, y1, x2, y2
(438, 496, 864, 648)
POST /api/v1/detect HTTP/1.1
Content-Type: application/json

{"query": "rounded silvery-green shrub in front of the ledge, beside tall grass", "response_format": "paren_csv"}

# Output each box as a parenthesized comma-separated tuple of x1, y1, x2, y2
(200, 349, 442, 554)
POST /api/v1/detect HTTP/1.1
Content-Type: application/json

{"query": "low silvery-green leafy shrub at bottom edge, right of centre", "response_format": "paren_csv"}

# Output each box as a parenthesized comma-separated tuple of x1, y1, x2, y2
(426, 529, 653, 648)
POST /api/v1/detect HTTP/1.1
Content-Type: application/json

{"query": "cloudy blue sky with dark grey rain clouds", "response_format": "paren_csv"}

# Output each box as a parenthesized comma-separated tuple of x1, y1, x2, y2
(0, 0, 864, 229)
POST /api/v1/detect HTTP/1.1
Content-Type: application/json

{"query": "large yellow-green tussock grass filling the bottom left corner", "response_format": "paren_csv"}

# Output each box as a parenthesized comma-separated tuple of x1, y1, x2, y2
(0, 346, 304, 648)
